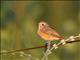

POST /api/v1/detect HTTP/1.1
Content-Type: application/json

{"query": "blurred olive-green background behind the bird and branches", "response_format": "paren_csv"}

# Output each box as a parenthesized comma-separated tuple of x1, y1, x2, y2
(0, 1, 80, 60)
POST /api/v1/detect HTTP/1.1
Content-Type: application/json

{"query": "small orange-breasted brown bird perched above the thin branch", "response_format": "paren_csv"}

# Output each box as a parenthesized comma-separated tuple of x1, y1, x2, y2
(37, 21, 64, 41)
